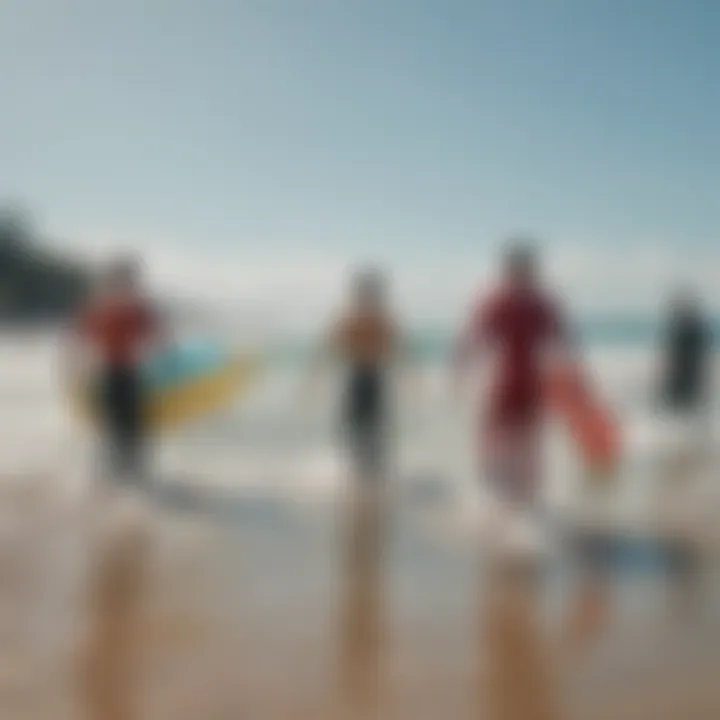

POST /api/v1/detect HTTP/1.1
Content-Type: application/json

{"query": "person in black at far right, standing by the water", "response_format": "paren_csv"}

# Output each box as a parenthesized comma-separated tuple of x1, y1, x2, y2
(658, 291, 712, 474)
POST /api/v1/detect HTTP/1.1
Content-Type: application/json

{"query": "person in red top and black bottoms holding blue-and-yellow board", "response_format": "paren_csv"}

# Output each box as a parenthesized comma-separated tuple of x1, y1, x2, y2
(65, 258, 164, 480)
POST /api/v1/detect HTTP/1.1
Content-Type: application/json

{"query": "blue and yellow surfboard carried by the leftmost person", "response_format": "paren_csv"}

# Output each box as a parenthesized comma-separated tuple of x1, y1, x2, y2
(72, 343, 261, 431)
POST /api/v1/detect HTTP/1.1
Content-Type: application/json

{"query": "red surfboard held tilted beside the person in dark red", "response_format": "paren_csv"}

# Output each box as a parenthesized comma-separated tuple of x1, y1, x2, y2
(546, 363, 620, 475)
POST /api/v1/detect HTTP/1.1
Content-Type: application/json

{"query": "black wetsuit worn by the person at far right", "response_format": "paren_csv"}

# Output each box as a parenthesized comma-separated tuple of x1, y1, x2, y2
(661, 314, 711, 412)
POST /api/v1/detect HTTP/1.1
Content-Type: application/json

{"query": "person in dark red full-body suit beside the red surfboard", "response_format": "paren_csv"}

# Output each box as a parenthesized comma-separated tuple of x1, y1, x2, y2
(455, 241, 568, 505)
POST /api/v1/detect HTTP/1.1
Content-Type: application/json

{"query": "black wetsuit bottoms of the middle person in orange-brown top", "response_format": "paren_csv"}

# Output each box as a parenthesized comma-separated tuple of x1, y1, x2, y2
(343, 363, 388, 481)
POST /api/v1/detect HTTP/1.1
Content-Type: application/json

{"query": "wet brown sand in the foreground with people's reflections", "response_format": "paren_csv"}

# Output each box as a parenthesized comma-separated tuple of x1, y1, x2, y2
(0, 472, 720, 720)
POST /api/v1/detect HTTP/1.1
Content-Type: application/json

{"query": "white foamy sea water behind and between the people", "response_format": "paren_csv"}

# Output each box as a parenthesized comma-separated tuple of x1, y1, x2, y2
(0, 319, 720, 540)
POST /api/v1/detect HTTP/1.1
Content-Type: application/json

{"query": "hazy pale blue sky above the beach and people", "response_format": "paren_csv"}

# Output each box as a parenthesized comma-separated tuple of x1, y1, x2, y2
(0, 0, 720, 320)
